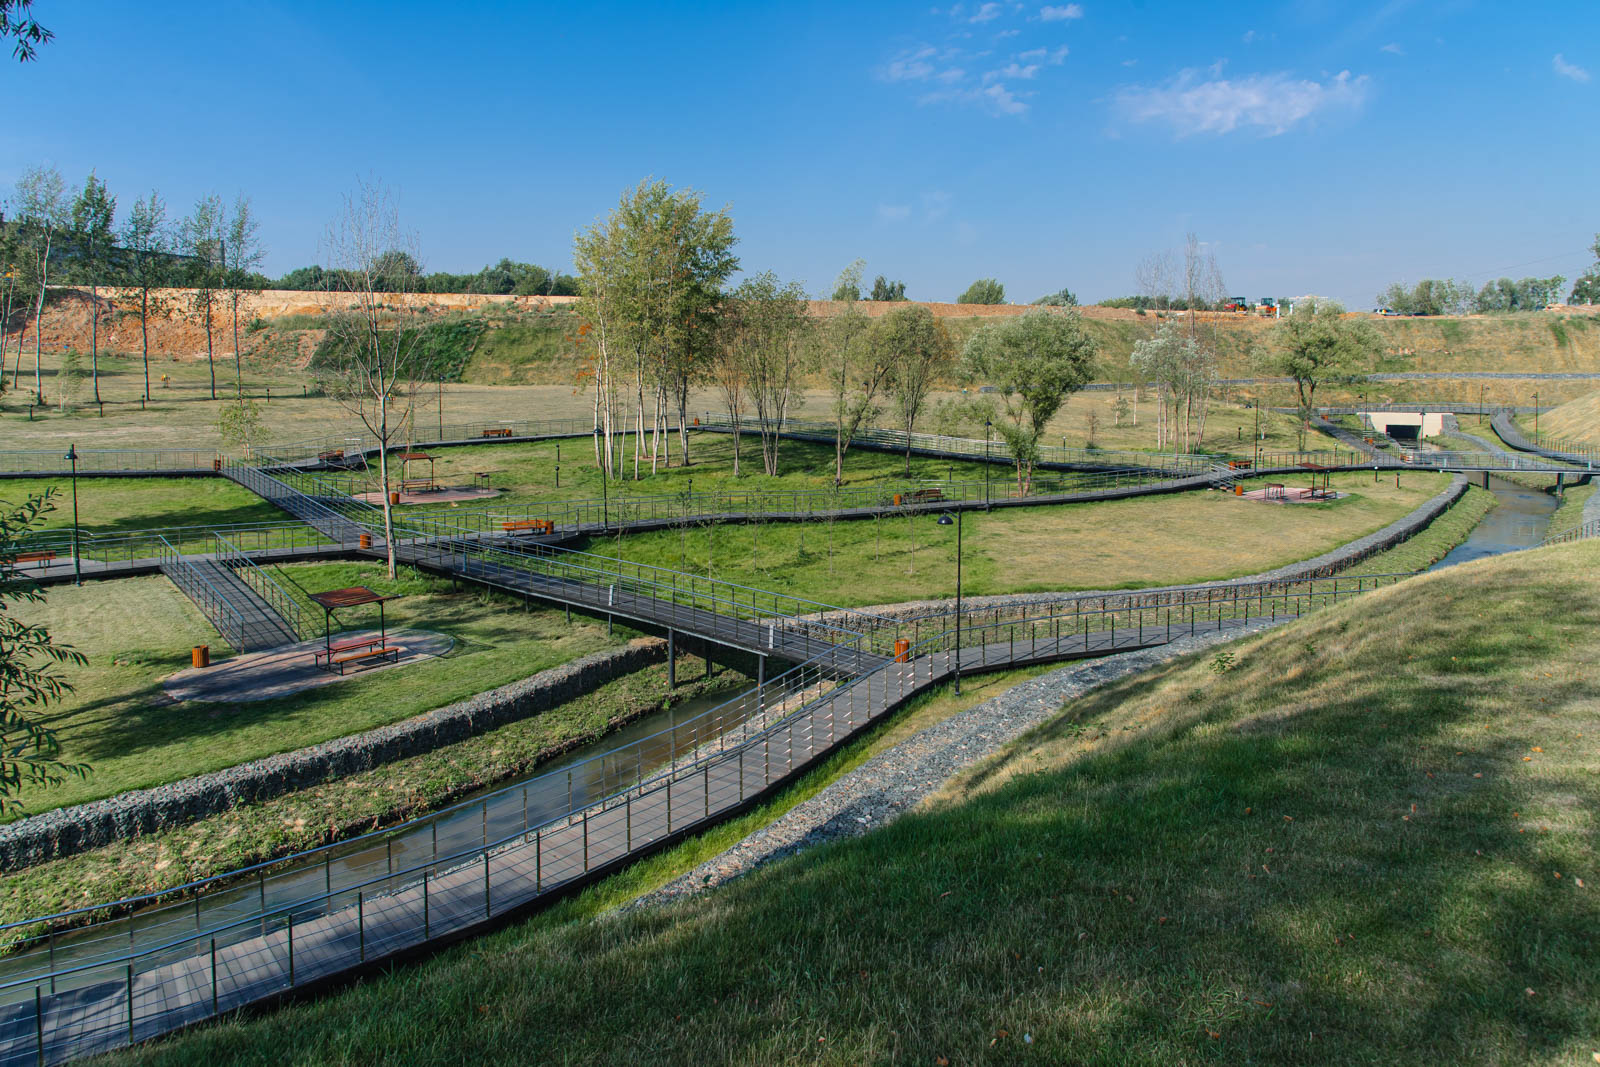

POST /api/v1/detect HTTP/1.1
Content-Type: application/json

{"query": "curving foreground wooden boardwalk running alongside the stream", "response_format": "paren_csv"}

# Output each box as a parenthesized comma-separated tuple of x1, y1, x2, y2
(0, 621, 1243, 1067)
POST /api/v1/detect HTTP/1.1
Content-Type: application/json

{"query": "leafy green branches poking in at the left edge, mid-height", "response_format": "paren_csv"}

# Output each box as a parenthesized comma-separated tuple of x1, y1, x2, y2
(0, 490, 90, 814)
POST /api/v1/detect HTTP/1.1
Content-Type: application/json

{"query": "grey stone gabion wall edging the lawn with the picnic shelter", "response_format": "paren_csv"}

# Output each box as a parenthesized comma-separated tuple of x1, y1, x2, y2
(0, 638, 667, 870)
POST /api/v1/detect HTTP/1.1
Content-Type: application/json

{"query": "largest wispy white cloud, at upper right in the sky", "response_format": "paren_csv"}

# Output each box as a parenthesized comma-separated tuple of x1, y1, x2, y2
(1115, 70, 1368, 138)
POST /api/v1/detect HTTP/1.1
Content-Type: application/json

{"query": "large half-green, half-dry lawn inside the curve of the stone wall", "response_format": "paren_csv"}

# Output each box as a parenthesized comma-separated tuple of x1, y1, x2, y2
(589, 472, 1448, 606)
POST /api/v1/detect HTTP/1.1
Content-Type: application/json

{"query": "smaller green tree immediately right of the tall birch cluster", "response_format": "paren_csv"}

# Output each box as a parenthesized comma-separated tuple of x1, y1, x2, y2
(723, 270, 811, 477)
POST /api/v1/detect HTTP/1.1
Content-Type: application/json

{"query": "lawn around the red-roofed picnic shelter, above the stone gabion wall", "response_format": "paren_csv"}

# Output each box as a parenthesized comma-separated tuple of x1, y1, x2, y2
(16, 563, 627, 813)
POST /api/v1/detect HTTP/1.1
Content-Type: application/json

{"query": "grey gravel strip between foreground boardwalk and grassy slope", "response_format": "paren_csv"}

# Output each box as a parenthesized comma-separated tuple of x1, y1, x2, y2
(619, 619, 1288, 912)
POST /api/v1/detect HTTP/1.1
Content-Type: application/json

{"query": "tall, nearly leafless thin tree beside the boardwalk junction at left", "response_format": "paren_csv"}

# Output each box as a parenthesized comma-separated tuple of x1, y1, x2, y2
(326, 181, 422, 579)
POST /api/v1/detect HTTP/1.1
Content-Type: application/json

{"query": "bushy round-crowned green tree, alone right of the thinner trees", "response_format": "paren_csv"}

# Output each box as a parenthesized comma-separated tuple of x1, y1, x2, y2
(962, 310, 1098, 496)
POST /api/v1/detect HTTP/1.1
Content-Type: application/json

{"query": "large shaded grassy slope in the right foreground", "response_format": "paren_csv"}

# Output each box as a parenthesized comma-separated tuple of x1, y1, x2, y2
(116, 544, 1600, 1065)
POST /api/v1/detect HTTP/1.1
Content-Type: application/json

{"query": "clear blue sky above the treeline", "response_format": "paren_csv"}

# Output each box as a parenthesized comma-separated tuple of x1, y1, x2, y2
(0, 0, 1600, 306)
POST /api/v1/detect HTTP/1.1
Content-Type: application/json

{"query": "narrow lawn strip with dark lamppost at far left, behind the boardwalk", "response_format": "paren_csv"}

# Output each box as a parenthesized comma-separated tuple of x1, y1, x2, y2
(0, 478, 294, 537)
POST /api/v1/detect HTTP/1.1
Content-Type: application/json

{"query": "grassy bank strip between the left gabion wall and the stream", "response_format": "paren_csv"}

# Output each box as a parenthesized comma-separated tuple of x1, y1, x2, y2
(0, 657, 744, 921)
